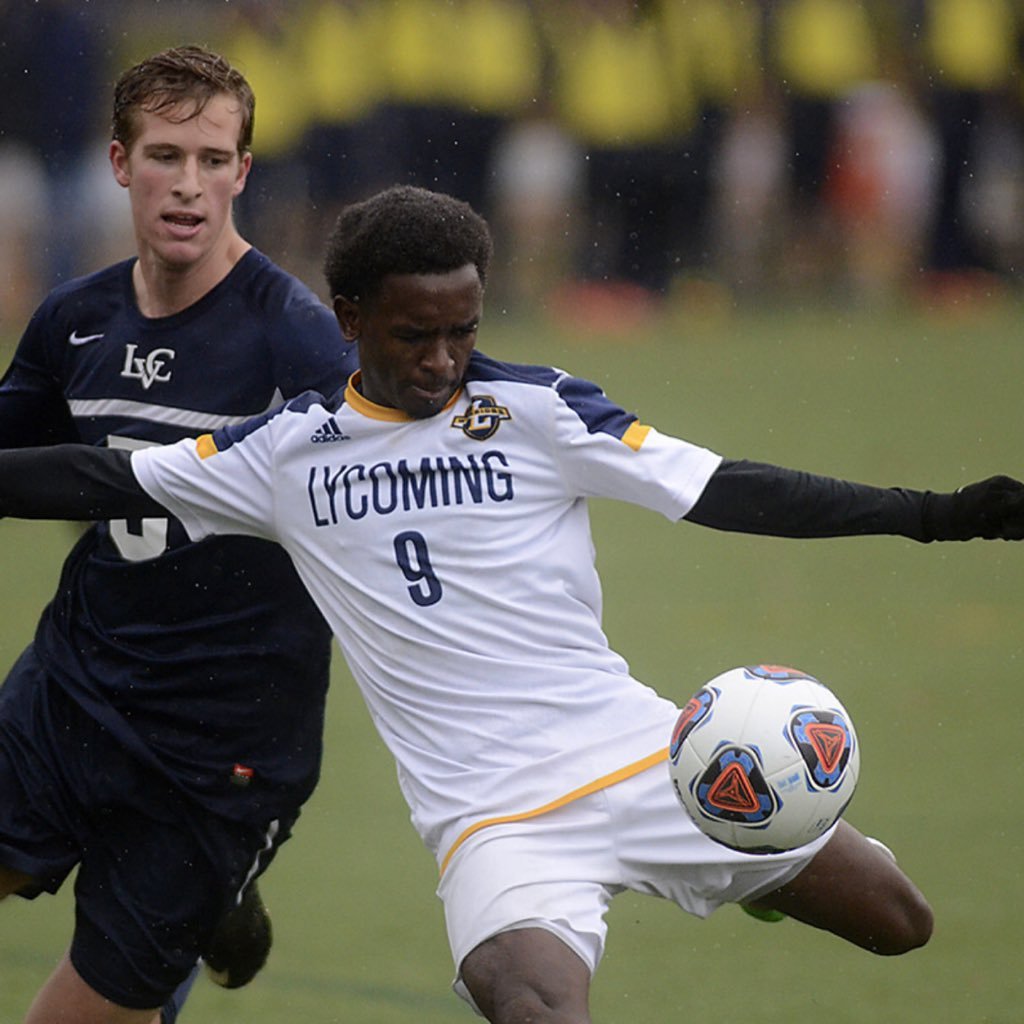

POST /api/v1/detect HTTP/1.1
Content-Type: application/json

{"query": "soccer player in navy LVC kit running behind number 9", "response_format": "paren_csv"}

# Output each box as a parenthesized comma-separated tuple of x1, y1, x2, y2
(0, 46, 352, 1024)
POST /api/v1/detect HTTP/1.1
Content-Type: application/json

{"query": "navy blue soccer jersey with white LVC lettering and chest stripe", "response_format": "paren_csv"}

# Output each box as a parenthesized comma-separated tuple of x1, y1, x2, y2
(0, 250, 355, 819)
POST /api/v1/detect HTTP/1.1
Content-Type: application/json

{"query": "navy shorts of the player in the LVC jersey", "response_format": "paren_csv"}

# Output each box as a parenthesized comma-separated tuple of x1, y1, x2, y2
(0, 648, 297, 1010)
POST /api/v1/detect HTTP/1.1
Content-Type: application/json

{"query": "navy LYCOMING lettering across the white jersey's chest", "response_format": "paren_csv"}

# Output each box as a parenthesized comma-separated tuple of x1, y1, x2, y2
(307, 450, 514, 526)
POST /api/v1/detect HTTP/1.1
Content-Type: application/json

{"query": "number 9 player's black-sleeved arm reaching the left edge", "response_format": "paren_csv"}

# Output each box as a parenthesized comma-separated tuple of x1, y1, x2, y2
(0, 444, 167, 519)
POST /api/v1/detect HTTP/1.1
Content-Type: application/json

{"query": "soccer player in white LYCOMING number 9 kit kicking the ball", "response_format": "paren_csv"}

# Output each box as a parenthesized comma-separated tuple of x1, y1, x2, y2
(0, 187, 1024, 1024)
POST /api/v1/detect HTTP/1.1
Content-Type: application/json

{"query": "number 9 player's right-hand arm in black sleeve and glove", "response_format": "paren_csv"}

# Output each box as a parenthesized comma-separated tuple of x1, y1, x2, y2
(685, 460, 1024, 543)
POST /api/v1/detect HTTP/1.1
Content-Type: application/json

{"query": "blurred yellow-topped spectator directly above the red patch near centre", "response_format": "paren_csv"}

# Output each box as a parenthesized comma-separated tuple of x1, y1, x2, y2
(544, 0, 697, 311)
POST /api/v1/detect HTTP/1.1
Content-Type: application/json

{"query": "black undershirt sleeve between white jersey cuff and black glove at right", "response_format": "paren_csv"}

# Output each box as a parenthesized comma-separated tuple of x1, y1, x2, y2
(685, 460, 934, 542)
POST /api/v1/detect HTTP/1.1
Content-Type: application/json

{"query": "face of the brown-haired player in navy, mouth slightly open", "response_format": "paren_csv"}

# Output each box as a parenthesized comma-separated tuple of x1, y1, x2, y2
(111, 94, 252, 268)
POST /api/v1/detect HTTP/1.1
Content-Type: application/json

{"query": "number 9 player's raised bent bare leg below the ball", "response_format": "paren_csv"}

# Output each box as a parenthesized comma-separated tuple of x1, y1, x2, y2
(753, 821, 933, 955)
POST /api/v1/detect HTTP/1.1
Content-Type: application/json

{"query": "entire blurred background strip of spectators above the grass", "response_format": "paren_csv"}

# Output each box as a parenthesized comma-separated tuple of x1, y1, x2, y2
(0, 0, 1024, 331)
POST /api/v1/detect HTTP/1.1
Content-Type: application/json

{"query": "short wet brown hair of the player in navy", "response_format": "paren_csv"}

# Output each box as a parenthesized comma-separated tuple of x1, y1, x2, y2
(112, 46, 256, 157)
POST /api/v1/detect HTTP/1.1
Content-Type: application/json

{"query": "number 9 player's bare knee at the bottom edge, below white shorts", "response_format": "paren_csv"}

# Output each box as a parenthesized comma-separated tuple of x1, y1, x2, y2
(461, 928, 590, 1024)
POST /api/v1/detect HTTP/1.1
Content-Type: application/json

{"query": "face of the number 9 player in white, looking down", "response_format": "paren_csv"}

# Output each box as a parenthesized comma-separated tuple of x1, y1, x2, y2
(334, 264, 483, 420)
